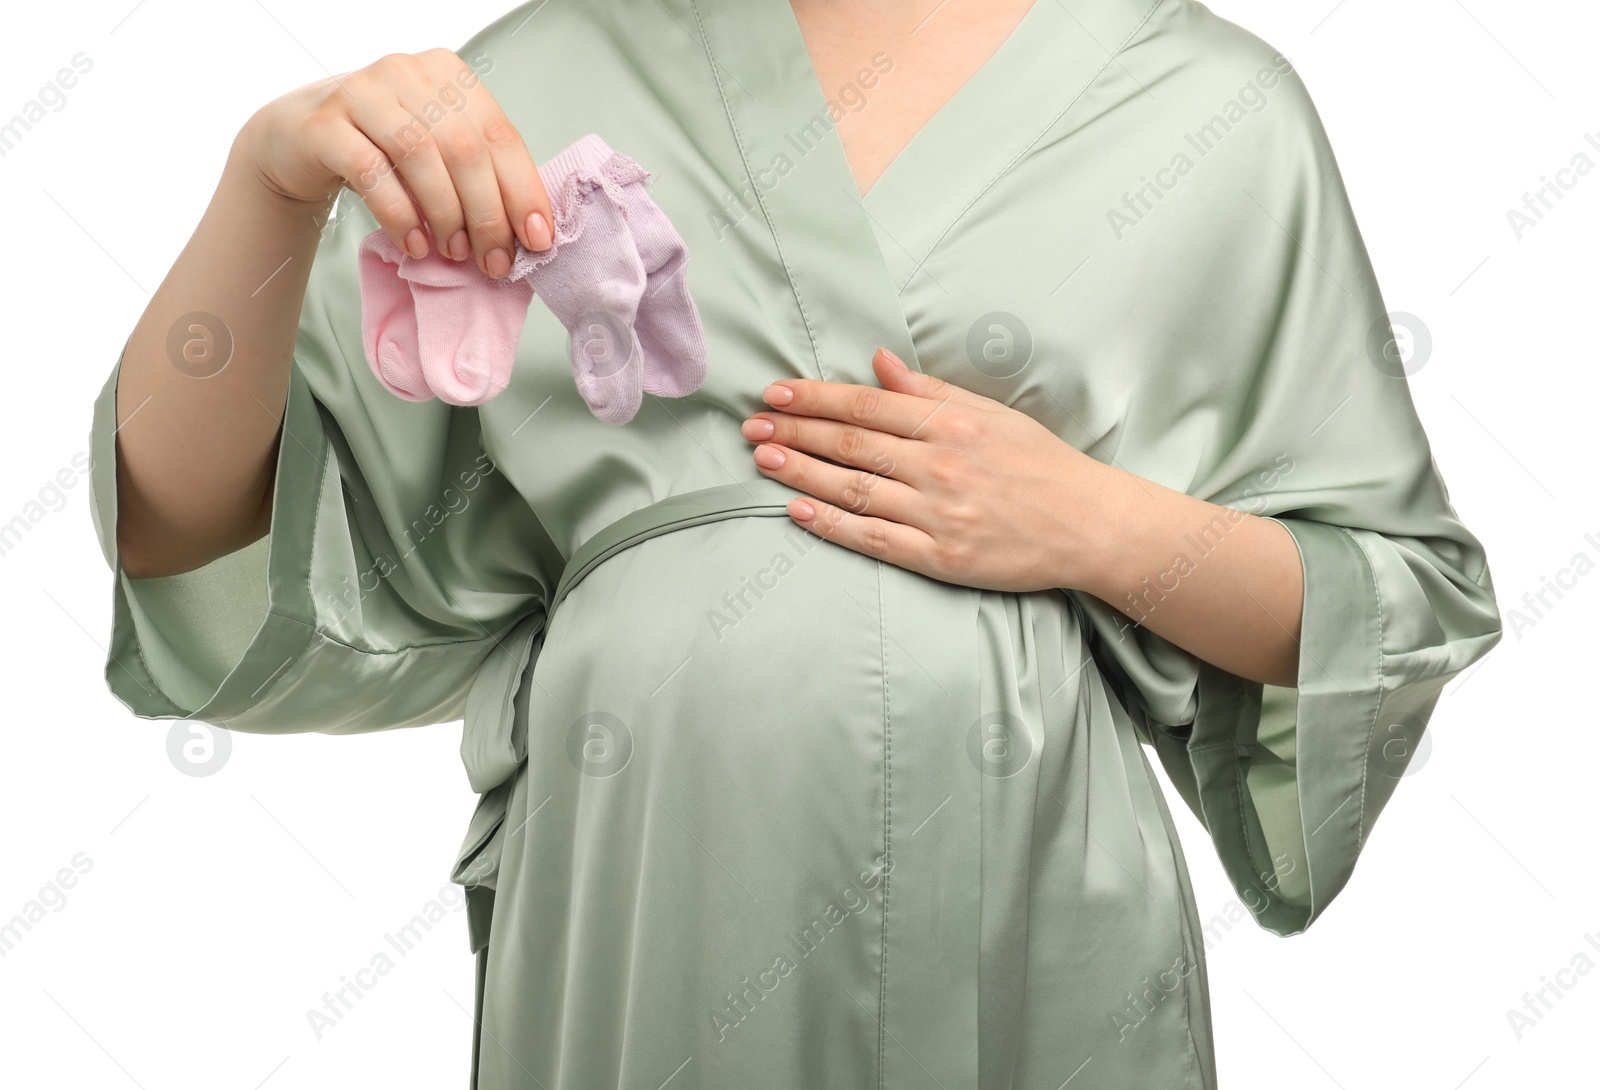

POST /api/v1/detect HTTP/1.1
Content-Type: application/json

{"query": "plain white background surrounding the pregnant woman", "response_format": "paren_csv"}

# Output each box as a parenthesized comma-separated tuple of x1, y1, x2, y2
(0, 0, 1600, 1090)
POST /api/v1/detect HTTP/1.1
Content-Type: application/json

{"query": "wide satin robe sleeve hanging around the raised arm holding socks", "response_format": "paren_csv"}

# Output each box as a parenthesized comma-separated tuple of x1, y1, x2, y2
(90, 192, 557, 735)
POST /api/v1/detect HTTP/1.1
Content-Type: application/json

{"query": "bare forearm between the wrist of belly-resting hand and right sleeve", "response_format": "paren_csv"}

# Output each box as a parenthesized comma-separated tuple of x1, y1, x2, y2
(1083, 467, 1304, 687)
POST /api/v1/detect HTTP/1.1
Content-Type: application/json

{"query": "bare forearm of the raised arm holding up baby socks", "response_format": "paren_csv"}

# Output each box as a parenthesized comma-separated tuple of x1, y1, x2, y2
(117, 124, 326, 578)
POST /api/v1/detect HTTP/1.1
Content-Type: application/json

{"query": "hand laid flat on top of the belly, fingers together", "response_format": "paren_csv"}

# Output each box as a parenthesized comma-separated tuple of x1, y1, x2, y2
(741, 349, 1130, 592)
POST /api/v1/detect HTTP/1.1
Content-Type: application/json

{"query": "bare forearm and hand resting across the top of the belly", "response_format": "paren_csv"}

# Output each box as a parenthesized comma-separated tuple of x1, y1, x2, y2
(741, 349, 1304, 687)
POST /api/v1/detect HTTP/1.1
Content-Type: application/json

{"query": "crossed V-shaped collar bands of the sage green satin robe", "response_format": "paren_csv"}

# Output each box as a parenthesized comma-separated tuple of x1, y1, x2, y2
(688, 0, 1162, 386)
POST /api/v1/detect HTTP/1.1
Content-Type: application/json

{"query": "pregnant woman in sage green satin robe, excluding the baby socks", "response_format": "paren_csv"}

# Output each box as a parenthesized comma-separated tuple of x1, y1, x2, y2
(93, 0, 1501, 1090)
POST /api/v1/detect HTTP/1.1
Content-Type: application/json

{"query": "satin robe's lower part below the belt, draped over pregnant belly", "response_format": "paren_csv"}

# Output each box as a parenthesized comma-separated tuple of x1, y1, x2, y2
(483, 517, 1186, 1085)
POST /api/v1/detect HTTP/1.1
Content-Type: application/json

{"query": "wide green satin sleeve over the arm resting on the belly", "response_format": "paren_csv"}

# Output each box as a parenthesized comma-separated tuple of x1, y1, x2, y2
(1075, 55, 1501, 935)
